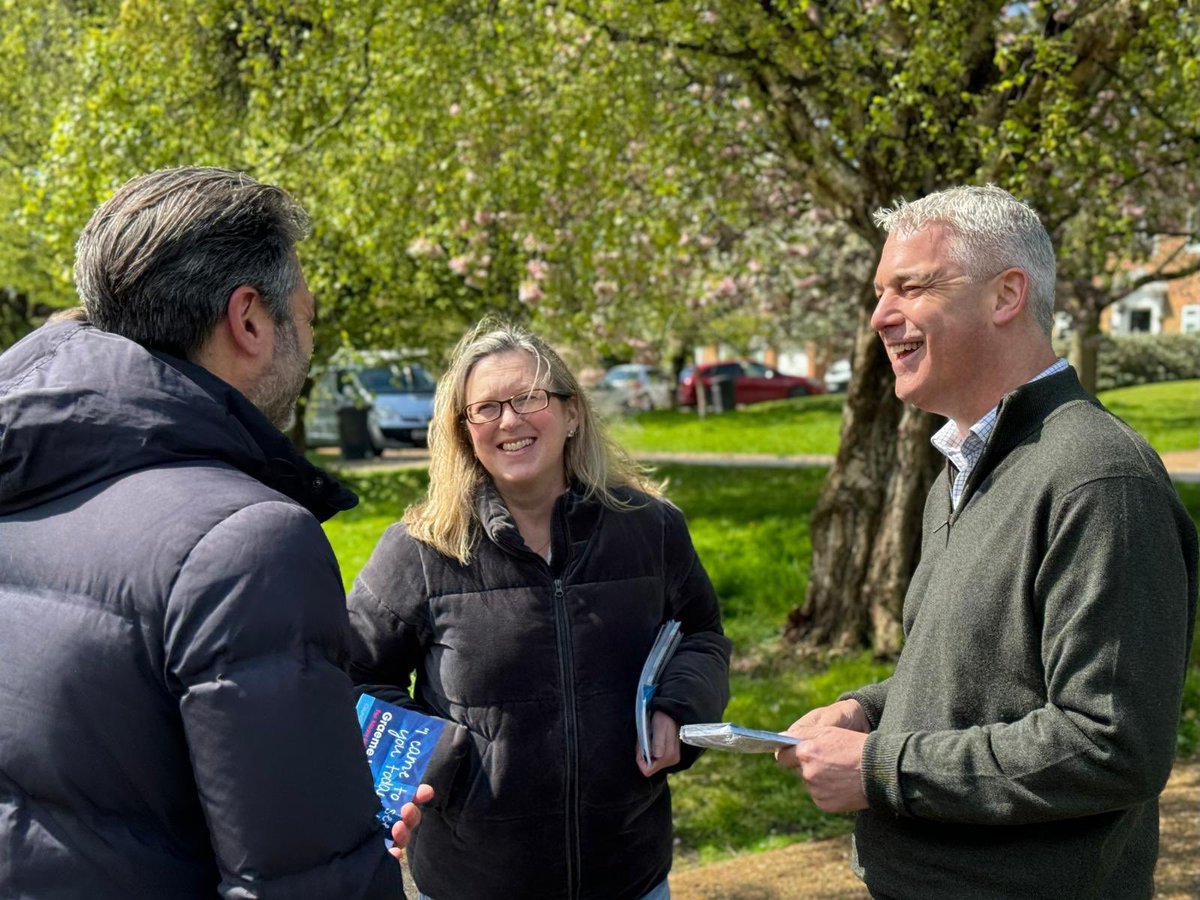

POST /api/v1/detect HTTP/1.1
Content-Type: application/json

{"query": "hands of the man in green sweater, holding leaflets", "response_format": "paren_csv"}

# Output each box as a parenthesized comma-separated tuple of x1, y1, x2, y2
(775, 700, 870, 812)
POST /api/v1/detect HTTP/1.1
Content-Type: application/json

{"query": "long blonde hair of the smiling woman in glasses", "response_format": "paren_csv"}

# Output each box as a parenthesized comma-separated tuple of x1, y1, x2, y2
(403, 318, 662, 565)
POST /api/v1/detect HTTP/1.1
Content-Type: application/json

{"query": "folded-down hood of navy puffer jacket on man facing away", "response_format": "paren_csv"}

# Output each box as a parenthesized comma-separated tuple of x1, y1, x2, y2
(0, 322, 356, 520)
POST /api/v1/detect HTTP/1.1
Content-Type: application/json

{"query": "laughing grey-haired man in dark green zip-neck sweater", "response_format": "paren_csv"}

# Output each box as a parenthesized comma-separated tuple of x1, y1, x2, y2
(779, 186, 1196, 900)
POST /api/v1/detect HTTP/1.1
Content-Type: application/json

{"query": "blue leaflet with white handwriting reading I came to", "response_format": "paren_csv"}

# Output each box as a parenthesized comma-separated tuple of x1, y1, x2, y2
(358, 694, 446, 830)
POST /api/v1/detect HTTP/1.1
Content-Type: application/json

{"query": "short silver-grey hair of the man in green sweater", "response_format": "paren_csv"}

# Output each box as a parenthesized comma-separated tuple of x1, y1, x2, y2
(874, 185, 1055, 335)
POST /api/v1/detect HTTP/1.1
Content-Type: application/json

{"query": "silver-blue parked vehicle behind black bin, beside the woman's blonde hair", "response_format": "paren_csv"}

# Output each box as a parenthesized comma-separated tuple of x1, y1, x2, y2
(304, 350, 436, 454)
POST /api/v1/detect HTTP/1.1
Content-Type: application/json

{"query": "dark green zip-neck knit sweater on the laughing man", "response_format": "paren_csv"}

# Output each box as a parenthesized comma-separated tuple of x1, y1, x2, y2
(847, 370, 1196, 900)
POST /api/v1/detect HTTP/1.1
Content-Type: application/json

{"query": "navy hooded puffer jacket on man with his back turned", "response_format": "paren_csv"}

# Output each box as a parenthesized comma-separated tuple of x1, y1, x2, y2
(0, 323, 401, 900)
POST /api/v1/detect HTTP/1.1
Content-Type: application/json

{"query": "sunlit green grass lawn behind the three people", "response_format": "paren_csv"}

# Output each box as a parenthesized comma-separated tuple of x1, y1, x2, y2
(325, 382, 1200, 862)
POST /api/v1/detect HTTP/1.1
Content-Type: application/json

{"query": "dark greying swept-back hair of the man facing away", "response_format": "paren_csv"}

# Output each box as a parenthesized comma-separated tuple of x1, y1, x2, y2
(74, 167, 311, 358)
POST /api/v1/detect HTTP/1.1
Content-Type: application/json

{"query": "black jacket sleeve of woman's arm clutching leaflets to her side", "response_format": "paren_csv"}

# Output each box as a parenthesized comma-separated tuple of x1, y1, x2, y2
(650, 504, 731, 772)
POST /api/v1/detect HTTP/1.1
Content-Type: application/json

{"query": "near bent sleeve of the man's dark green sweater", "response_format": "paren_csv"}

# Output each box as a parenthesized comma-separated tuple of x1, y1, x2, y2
(863, 476, 1195, 824)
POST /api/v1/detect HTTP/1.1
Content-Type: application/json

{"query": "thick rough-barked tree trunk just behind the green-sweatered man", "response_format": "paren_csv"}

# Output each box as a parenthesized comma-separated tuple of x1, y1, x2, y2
(785, 288, 941, 655)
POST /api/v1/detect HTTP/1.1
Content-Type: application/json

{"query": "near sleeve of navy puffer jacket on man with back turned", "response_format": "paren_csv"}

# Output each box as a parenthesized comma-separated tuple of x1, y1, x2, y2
(163, 502, 403, 900)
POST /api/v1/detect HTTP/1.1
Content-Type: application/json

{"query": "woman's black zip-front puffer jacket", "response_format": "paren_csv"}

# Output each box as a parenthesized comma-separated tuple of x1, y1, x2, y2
(349, 488, 730, 900)
